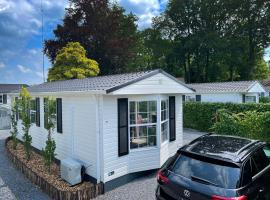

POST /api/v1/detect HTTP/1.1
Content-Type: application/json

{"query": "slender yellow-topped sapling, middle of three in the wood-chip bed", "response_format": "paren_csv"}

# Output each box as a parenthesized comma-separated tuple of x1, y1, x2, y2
(19, 87, 32, 160)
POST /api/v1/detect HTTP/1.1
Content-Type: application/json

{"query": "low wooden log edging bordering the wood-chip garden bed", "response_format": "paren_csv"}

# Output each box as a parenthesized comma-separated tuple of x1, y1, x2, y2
(5, 137, 104, 200)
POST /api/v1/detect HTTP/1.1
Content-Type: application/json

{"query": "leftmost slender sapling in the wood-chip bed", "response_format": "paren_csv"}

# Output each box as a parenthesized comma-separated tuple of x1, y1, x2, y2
(10, 100, 18, 149)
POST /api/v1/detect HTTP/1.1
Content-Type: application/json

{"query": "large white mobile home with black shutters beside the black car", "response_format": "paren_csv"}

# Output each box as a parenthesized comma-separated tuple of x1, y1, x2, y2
(14, 70, 193, 191)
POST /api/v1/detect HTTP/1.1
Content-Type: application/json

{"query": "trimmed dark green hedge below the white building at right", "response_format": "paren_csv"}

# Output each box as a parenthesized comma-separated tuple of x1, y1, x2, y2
(183, 102, 270, 131)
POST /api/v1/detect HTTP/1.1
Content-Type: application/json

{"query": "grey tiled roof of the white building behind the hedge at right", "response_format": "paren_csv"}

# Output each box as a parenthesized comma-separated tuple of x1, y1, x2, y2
(187, 81, 258, 93)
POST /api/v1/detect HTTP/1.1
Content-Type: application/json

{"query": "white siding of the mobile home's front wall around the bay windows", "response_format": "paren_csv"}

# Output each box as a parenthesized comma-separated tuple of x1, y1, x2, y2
(103, 95, 183, 182)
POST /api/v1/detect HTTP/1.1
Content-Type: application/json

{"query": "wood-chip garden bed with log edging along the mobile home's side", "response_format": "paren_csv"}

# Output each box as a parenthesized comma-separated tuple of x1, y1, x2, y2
(6, 138, 103, 200)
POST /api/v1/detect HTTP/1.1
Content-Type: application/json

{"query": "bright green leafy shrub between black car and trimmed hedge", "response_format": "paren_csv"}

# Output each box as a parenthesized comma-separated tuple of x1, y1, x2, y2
(211, 109, 270, 142)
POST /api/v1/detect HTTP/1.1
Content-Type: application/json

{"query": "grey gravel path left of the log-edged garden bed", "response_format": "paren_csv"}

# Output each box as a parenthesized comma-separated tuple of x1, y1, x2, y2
(0, 130, 50, 200)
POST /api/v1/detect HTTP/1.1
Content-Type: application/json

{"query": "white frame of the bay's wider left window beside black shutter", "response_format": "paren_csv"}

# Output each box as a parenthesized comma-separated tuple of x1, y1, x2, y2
(128, 99, 159, 151)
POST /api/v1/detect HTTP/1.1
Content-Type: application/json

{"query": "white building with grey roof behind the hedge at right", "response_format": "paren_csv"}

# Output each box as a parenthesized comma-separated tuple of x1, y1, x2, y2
(183, 81, 266, 103)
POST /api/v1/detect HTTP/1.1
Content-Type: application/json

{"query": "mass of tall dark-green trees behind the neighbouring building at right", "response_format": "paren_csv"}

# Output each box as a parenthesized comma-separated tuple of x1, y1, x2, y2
(151, 0, 270, 82)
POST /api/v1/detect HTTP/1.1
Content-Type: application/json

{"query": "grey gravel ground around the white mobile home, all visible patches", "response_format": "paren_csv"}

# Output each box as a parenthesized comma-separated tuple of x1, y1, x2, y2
(0, 129, 203, 200)
